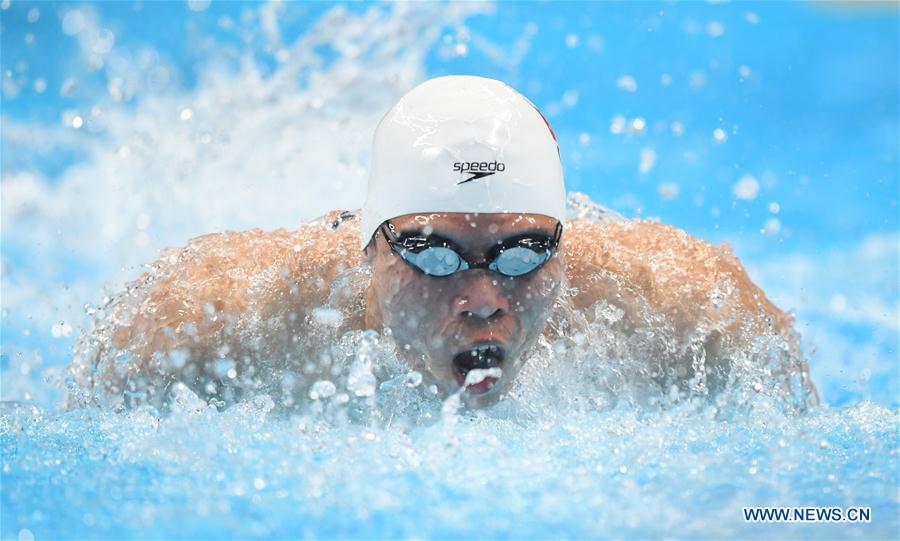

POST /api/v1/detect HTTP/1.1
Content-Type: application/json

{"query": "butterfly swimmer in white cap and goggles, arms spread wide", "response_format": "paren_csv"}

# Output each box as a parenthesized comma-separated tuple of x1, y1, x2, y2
(70, 76, 817, 409)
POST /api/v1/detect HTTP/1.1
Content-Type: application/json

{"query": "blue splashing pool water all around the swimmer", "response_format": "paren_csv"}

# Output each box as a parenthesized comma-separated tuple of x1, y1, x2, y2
(0, 1, 900, 539)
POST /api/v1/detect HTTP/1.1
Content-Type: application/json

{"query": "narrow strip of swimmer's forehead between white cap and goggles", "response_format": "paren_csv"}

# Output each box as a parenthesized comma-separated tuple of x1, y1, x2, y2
(390, 212, 557, 236)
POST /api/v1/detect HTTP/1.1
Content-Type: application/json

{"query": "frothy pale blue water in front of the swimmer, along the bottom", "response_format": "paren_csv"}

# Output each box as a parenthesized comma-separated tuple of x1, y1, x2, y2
(0, 384, 900, 538)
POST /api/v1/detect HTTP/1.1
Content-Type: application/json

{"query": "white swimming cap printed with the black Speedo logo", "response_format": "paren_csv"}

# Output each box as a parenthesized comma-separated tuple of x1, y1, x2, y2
(361, 75, 566, 247)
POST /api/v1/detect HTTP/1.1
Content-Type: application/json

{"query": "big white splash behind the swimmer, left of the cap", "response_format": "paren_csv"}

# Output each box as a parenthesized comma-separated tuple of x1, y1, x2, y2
(0, 2, 487, 396)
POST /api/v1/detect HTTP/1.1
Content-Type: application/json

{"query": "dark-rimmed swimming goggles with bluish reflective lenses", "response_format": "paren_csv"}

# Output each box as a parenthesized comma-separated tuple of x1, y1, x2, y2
(381, 222, 562, 277)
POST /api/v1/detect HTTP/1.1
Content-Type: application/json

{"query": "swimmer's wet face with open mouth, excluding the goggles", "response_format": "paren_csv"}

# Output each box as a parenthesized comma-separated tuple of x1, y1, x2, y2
(369, 213, 565, 405)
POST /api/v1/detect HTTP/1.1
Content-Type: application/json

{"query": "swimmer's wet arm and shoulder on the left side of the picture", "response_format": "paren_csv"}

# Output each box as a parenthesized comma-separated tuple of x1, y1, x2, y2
(70, 213, 359, 402)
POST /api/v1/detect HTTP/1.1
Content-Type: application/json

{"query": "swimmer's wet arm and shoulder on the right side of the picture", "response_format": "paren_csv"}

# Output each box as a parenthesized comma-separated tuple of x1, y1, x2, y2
(564, 217, 818, 403)
